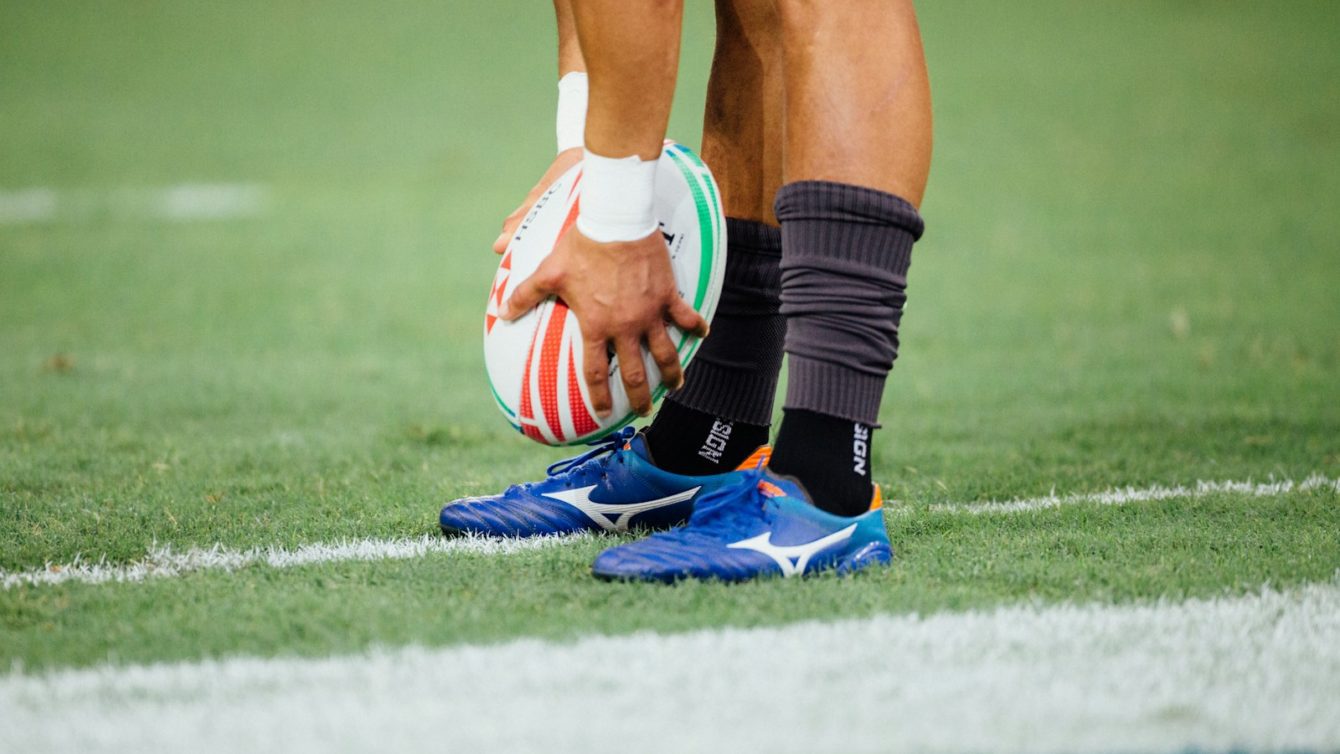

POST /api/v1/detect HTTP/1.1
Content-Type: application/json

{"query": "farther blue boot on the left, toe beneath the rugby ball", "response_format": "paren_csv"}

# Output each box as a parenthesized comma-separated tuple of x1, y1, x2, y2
(438, 427, 771, 537)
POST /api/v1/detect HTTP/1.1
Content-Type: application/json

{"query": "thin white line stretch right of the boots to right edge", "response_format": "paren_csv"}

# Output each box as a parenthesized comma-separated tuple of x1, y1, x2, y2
(930, 474, 1340, 513)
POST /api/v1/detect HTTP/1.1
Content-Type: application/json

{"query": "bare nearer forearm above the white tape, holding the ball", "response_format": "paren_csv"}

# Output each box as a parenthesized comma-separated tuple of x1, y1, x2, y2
(571, 0, 683, 159)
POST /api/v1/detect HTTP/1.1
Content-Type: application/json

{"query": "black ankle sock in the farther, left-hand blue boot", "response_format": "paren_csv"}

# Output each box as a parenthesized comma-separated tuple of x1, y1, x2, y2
(642, 400, 768, 475)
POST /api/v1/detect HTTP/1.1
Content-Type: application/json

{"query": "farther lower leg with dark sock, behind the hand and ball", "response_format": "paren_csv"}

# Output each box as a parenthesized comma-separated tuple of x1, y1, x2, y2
(646, 0, 785, 474)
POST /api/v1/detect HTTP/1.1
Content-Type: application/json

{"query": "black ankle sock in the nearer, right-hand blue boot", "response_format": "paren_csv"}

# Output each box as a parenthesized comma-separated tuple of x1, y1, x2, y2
(768, 408, 875, 516)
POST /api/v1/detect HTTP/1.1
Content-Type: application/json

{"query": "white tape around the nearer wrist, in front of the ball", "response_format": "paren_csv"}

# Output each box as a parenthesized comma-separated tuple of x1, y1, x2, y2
(578, 150, 659, 244)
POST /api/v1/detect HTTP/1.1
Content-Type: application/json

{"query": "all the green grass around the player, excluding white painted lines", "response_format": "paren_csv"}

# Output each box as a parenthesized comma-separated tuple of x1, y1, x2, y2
(0, 1, 1340, 664)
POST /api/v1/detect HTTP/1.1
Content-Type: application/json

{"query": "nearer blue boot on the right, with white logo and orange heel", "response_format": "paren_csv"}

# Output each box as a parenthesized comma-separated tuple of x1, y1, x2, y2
(591, 469, 894, 583)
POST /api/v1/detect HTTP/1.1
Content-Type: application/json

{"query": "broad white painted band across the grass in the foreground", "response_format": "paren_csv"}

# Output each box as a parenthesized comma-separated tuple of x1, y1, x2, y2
(0, 581, 1340, 754)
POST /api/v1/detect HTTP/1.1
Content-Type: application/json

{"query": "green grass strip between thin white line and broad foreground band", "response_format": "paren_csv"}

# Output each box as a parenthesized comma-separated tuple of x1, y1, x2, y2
(0, 490, 1340, 670)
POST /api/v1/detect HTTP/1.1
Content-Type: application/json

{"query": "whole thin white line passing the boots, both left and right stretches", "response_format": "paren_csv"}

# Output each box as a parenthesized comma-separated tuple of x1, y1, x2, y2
(0, 475, 1340, 589)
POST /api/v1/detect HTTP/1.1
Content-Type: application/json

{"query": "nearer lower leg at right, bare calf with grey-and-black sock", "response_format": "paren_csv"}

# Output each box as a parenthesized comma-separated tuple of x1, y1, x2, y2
(771, 0, 931, 516)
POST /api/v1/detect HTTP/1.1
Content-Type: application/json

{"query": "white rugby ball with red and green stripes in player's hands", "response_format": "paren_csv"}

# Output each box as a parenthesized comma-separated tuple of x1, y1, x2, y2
(484, 142, 726, 445)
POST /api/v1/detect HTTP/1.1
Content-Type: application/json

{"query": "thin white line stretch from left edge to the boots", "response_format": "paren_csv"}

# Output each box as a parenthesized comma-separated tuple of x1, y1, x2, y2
(0, 534, 580, 589)
